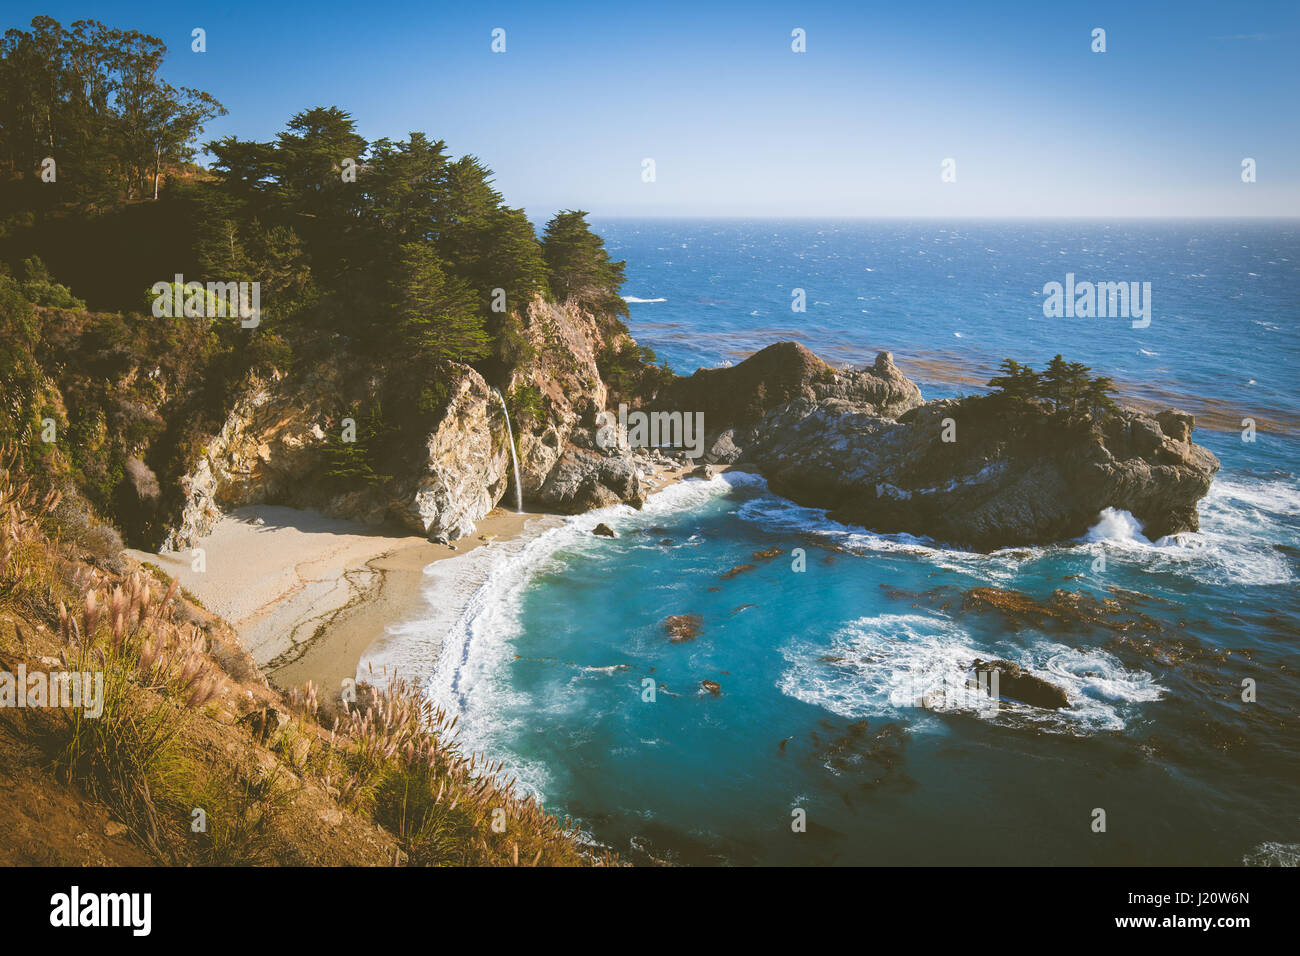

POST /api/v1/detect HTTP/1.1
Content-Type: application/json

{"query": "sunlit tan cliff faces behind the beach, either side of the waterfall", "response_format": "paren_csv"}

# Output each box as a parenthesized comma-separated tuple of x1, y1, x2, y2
(156, 299, 650, 550)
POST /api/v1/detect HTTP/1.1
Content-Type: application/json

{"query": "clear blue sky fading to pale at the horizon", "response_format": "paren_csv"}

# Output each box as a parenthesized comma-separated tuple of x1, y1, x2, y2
(10, 0, 1300, 221)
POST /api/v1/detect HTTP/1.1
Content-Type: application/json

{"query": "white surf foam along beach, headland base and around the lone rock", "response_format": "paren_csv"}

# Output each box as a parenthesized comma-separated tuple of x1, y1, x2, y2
(392, 471, 1300, 795)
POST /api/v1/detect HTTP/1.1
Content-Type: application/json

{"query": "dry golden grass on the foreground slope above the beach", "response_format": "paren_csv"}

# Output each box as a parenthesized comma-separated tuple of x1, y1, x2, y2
(0, 455, 618, 866)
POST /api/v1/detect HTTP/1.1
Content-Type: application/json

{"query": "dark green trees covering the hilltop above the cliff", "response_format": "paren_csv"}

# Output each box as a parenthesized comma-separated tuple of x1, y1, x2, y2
(0, 17, 627, 421)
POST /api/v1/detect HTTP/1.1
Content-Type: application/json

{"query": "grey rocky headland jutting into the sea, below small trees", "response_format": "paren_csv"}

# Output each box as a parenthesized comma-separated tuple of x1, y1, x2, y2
(697, 345, 1218, 550)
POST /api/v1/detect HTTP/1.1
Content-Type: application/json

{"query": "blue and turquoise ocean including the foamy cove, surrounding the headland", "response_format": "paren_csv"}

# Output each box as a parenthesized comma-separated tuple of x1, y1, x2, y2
(363, 220, 1300, 865)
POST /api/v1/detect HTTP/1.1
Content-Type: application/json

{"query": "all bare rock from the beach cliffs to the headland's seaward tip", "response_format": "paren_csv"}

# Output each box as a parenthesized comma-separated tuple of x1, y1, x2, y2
(149, 314, 1218, 549)
